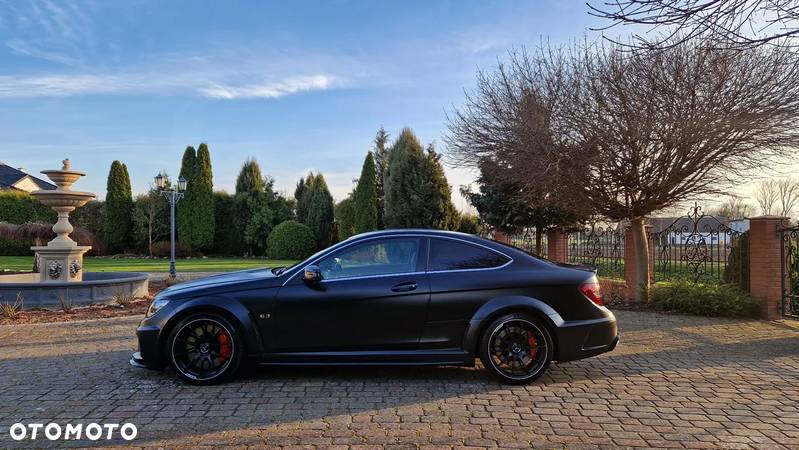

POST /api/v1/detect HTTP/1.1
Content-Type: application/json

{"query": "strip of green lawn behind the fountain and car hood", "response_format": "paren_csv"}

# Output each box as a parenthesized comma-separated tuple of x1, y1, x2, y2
(0, 256, 296, 272)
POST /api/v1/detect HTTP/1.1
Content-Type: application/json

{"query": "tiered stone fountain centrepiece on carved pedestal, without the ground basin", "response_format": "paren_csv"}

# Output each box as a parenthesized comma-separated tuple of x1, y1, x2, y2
(31, 159, 95, 283)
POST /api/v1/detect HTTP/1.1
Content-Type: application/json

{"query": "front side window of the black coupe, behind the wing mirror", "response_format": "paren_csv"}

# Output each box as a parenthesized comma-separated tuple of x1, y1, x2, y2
(319, 238, 421, 280)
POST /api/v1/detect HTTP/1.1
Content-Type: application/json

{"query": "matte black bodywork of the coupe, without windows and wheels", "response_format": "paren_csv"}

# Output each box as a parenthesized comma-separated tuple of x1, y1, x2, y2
(131, 230, 618, 376)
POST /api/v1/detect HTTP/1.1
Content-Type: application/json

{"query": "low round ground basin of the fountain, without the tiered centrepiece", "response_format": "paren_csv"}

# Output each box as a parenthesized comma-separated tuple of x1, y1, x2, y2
(0, 272, 149, 309)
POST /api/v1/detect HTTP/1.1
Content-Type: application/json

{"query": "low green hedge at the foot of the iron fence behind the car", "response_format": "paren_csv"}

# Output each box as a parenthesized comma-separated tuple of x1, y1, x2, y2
(649, 281, 759, 317)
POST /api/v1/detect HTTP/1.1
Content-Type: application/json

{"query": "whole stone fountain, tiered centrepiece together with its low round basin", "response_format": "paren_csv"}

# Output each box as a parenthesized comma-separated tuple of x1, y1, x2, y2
(0, 159, 149, 308)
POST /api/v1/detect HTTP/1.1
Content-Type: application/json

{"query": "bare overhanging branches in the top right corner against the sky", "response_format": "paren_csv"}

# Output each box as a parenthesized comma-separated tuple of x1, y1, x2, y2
(587, 0, 799, 49)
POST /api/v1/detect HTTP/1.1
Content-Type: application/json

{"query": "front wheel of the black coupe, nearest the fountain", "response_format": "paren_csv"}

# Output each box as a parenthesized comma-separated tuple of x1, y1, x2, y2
(166, 313, 244, 385)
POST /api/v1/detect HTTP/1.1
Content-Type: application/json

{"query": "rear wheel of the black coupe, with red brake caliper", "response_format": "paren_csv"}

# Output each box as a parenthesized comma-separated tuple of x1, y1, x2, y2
(479, 313, 555, 384)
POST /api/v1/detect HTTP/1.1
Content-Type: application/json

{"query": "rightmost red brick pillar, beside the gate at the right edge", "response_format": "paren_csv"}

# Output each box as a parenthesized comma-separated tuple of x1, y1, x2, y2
(749, 216, 788, 319)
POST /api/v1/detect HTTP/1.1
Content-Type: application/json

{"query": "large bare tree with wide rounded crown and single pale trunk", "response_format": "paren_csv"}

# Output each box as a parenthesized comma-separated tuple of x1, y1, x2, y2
(449, 42, 799, 299)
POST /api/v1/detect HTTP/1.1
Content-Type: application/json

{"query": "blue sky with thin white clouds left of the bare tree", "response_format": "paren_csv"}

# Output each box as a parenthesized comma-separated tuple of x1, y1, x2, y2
(0, 0, 608, 209)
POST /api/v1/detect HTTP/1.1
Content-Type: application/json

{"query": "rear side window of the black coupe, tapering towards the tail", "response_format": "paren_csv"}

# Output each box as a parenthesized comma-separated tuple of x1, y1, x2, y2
(427, 239, 510, 272)
